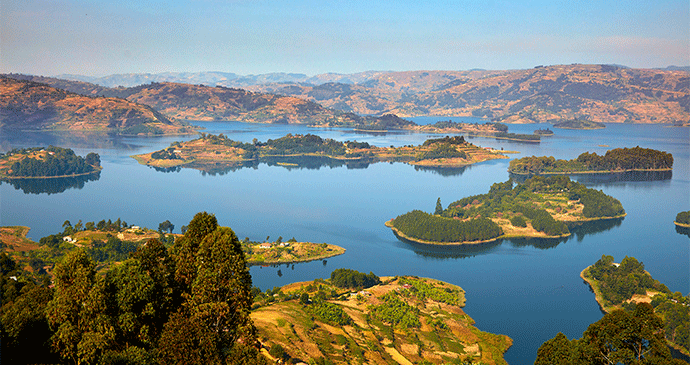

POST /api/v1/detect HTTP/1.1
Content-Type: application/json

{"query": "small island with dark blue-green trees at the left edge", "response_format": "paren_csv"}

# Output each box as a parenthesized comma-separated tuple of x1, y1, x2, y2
(7, 146, 101, 177)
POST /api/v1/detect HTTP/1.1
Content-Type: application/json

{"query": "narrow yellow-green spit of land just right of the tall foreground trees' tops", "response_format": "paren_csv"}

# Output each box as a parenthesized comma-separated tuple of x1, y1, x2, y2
(242, 237, 345, 265)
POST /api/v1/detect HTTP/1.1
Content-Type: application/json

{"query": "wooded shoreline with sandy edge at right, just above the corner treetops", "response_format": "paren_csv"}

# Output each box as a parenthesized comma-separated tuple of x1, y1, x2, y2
(580, 255, 690, 357)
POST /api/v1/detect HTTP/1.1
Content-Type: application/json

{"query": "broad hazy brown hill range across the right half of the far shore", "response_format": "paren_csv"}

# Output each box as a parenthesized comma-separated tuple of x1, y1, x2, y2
(249, 65, 690, 123)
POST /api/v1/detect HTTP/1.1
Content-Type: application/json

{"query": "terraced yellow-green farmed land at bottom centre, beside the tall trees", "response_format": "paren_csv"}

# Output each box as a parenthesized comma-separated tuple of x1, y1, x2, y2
(251, 269, 512, 364)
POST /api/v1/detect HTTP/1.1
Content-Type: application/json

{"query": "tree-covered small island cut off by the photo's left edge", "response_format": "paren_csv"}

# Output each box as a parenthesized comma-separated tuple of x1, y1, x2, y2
(0, 146, 102, 179)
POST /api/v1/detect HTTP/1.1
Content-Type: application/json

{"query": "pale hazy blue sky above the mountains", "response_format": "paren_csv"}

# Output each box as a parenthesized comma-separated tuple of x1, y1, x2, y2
(0, 0, 690, 76)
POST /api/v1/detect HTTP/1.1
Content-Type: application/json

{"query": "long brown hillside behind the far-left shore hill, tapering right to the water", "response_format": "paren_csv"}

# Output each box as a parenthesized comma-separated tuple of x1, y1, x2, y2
(7, 74, 412, 129)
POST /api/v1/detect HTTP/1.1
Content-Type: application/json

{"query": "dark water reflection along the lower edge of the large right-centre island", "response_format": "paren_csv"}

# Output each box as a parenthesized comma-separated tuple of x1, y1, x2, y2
(393, 218, 624, 260)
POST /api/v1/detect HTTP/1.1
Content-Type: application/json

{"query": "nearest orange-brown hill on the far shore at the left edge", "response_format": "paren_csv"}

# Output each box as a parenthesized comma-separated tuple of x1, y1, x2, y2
(0, 76, 193, 134)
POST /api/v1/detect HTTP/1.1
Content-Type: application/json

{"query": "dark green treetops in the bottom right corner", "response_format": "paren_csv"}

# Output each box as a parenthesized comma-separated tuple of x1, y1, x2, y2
(534, 303, 685, 365)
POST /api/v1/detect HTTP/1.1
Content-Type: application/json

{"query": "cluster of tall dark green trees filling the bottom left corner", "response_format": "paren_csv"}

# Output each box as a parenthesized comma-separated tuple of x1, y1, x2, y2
(0, 213, 265, 364)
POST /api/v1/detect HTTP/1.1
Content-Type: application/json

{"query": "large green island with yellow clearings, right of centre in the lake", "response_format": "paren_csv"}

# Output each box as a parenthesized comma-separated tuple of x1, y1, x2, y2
(386, 176, 625, 245)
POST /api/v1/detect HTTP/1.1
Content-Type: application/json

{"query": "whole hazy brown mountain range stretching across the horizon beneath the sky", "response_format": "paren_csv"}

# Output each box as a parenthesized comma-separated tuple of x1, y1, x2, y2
(0, 64, 690, 129)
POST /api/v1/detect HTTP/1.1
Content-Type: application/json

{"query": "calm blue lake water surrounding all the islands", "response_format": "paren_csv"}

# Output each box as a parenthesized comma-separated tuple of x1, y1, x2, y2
(0, 117, 690, 364)
